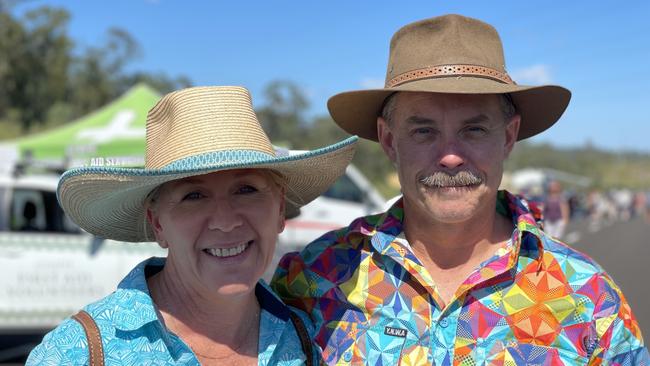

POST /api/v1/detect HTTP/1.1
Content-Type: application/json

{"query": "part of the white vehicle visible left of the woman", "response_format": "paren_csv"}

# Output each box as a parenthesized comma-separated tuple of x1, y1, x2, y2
(0, 174, 166, 364)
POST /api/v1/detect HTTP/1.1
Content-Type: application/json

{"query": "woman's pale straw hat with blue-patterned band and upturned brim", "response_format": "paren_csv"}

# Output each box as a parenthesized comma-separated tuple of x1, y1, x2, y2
(57, 86, 357, 242)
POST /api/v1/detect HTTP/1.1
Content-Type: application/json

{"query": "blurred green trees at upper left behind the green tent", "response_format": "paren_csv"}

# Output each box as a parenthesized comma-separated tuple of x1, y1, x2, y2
(0, 0, 191, 139)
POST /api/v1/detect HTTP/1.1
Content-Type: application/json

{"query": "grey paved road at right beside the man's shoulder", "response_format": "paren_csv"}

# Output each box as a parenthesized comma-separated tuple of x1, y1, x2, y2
(567, 218, 650, 340)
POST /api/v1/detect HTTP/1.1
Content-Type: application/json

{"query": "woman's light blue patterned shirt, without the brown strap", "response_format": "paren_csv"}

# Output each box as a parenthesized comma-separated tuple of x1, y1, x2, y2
(27, 258, 320, 366)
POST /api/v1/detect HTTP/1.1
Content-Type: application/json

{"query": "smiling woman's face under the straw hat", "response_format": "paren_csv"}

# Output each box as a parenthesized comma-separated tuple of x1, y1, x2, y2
(147, 169, 284, 295)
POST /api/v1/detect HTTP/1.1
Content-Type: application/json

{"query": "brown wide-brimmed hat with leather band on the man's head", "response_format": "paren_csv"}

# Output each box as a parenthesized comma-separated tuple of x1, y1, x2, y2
(327, 15, 571, 141)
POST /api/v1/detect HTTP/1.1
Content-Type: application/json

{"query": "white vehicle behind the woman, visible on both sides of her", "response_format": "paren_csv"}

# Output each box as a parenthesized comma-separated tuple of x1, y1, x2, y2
(0, 166, 384, 363)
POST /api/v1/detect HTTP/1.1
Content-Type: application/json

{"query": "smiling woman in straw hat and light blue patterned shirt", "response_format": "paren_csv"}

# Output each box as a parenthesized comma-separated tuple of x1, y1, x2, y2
(27, 87, 356, 365)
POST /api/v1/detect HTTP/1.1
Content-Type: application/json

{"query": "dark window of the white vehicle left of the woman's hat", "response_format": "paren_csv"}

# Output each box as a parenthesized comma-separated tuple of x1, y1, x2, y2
(10, 188, 79, 233)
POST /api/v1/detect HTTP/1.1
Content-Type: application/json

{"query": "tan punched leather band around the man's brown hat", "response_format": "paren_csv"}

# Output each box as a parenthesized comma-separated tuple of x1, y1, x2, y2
(386, 65, 515, 88)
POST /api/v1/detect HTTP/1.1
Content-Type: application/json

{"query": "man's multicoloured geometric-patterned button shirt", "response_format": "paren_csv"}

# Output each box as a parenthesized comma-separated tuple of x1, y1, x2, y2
(271, 191, 650, 365)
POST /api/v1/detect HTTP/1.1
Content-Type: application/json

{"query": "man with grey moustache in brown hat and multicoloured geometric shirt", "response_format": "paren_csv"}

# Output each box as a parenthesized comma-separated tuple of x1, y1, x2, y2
(273, 15, 649, 365)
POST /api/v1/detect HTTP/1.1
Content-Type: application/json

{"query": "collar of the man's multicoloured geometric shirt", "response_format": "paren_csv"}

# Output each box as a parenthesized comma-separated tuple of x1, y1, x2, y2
(347, 191, 544, 259)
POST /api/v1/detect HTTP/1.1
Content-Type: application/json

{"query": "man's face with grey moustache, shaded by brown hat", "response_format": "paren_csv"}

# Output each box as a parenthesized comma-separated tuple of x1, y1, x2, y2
(377, 92, 520, 223)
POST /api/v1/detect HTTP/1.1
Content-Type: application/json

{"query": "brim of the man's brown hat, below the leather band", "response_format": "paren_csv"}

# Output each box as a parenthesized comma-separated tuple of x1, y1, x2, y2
(327, 77, 571, 141)
